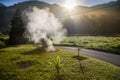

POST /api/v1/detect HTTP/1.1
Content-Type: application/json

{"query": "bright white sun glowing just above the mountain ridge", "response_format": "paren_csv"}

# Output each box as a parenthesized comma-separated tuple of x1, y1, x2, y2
(63, 0, 77, 10)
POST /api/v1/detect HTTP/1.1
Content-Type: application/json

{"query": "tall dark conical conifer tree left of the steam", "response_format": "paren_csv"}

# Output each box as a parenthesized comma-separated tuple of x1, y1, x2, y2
(8, 10, 26, 45)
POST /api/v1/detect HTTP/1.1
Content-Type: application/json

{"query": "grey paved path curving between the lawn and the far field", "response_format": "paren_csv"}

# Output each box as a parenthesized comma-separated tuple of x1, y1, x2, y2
(58, 46, 120, 67)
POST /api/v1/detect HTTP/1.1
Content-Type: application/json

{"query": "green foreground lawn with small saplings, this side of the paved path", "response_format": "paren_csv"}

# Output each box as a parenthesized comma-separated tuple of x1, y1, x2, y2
(0, 44, 120, 80)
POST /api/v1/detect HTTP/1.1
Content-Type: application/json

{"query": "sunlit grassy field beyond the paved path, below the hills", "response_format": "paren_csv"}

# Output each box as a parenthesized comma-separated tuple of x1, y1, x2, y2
(61, 36, 120, 54)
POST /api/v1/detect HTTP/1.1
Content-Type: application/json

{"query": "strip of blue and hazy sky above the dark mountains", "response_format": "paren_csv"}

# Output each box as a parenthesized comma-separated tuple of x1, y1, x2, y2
(0, 0, 116, 6)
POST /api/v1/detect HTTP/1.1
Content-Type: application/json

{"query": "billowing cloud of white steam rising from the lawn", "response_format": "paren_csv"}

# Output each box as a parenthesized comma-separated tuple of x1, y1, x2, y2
(25, 7, 66, 51)
